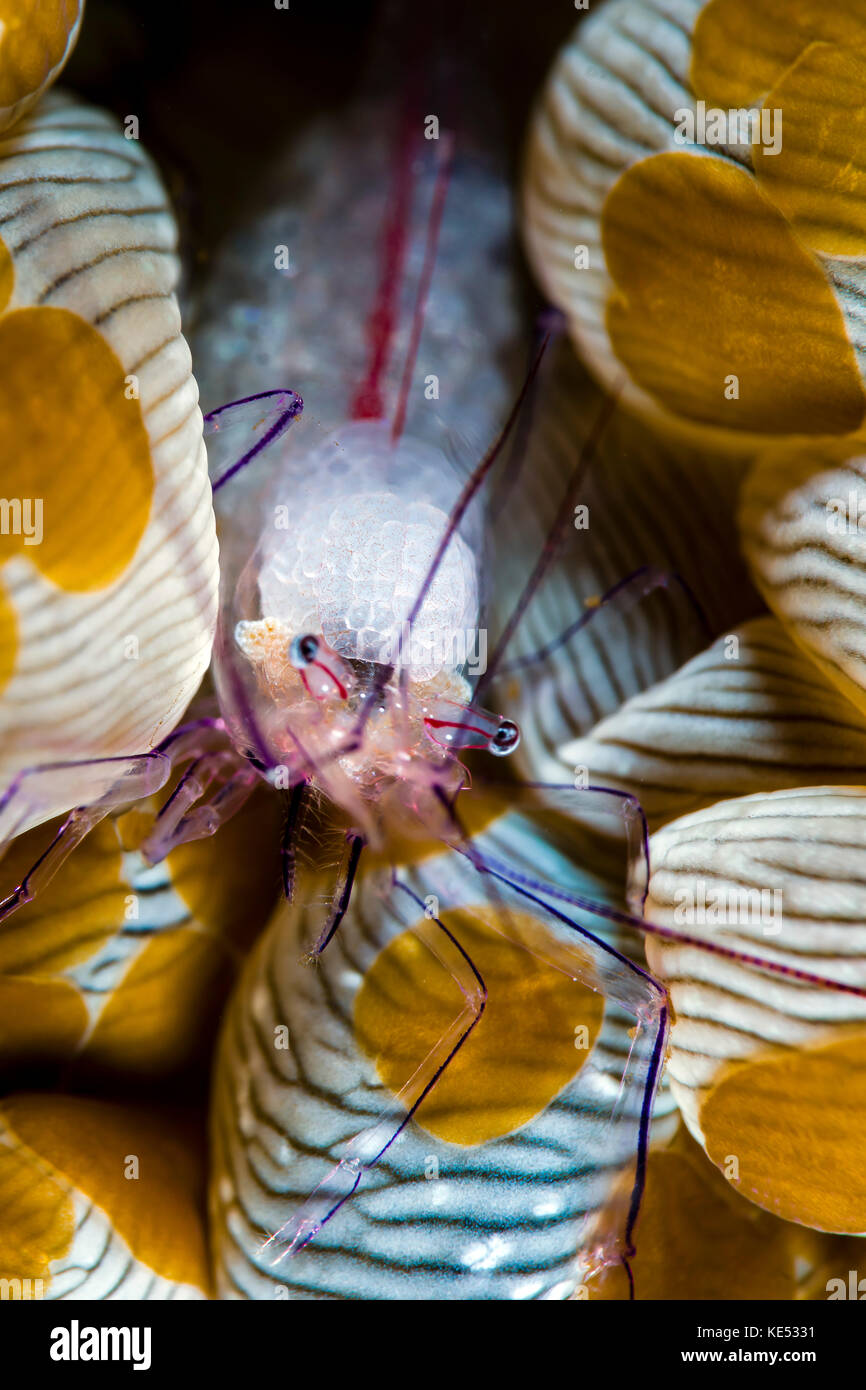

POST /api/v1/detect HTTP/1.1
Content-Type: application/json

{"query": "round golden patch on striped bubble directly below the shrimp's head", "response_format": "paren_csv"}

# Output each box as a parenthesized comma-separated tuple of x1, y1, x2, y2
(354, 908, 605, 1145)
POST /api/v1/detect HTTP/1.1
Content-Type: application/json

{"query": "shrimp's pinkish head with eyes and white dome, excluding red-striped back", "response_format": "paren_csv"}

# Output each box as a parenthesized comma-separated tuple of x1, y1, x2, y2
(219, 420, 518, 838)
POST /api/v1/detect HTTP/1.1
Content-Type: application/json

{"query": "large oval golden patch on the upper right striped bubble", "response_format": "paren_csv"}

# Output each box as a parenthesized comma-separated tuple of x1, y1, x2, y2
(602, 153, 866, 434)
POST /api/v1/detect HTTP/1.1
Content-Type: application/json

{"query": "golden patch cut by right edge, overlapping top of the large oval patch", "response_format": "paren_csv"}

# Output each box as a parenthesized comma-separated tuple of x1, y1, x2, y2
(755, 43, 866, 256)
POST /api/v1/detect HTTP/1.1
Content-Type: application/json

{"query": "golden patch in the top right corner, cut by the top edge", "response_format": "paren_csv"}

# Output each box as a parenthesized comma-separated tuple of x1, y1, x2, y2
(691, 0, 866, 107)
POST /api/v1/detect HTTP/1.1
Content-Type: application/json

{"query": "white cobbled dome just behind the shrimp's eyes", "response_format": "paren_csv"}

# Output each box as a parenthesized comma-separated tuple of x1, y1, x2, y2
(259, 421, 478, 684)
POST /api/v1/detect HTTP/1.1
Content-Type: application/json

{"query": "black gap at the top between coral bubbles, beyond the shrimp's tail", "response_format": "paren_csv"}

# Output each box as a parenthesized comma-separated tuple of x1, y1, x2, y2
(61, 0, 578, 270)
